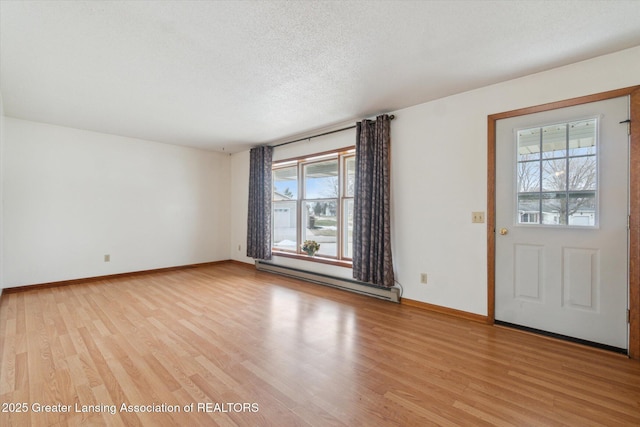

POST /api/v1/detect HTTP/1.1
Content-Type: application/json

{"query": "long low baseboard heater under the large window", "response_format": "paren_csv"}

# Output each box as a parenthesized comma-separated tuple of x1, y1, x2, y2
(256, 260, 400, 303)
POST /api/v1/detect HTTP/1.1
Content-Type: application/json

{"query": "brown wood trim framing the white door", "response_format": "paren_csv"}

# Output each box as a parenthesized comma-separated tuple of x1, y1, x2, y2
(487, 85, 640, 359)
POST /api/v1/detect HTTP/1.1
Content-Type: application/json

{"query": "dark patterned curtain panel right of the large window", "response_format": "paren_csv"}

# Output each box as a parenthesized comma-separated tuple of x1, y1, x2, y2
(353, 114, 394, 287)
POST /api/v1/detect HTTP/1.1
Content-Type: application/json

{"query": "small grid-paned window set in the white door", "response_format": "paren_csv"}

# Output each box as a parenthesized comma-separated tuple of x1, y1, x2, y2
(517, 119, 598, 227)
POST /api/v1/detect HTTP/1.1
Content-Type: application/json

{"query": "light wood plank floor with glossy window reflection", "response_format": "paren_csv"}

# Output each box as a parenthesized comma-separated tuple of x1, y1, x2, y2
(0, 263, 640, 426)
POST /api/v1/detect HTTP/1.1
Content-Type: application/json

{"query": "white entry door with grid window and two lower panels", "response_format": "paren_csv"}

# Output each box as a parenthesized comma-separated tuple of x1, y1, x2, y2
(495, 97, 629, 349)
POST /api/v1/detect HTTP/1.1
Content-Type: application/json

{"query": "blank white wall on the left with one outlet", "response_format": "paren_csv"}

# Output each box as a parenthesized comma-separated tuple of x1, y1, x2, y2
(3, 117, 230, 287)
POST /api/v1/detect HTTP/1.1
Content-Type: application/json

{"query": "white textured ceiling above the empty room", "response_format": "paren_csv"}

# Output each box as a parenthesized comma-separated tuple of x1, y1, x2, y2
(0, 0, 640, 152)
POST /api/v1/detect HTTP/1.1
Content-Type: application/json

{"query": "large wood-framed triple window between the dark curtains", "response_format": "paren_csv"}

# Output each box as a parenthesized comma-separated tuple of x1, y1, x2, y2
(272, 147, 355, 260)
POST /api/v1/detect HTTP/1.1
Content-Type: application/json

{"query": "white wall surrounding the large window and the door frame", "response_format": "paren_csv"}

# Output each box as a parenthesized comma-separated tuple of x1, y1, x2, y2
(231, 47, 640, 315)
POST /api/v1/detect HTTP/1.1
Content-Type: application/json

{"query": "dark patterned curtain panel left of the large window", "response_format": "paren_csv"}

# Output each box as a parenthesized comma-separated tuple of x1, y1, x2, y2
(247, 146, 273, 259)
